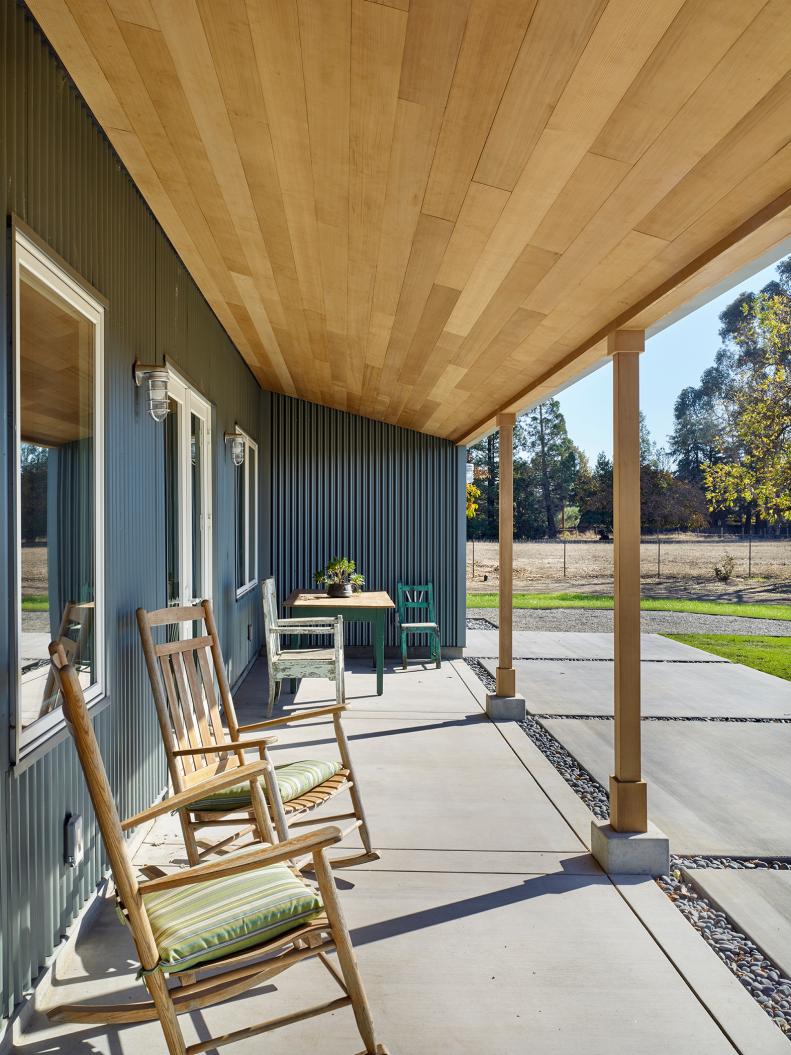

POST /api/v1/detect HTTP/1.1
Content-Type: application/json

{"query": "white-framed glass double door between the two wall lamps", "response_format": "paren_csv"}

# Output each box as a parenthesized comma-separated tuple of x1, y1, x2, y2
(165, 367, 212, 608)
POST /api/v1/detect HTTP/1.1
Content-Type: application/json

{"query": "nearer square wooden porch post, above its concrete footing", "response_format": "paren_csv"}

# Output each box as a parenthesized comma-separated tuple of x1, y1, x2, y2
(607, 330, 648, 831)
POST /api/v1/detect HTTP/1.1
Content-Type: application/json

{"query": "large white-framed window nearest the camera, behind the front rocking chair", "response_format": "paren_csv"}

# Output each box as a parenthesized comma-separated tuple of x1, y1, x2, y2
(14, 230, 104, 749)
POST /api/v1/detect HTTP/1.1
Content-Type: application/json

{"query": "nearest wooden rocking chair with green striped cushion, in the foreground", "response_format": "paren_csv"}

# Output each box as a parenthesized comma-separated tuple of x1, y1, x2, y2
(49, 641, 387, 1055)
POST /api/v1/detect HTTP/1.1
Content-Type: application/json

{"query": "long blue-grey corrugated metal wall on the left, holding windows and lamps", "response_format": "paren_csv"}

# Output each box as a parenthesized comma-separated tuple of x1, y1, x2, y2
(0, 0, 261, 1014)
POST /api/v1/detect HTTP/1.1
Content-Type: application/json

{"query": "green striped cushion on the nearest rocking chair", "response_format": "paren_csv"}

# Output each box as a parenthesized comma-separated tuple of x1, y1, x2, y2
(142, 864, 323, 972)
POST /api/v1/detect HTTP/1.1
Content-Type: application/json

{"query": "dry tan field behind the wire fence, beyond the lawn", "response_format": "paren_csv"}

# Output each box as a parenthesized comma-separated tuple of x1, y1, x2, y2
(467, 535, 791, 601)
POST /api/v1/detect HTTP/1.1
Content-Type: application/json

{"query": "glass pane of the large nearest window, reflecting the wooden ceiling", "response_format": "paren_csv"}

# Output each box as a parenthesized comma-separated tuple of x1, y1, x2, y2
(18, 269, 97, 729)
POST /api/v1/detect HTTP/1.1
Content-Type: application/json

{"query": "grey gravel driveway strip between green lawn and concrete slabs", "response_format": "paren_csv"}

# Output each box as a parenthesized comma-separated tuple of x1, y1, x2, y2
(467, 608, 791, 637)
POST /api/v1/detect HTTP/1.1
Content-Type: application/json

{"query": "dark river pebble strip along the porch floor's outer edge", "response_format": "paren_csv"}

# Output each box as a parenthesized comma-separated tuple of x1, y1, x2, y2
(465, 658, 791, 1040)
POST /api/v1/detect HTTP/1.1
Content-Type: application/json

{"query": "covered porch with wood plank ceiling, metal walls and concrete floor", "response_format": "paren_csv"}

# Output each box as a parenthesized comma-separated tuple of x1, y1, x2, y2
(0, 0, 791, 1055)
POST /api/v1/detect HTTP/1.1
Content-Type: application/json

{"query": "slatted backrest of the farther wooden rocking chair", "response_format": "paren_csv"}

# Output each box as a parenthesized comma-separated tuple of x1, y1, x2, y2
(137, 600, 244, 791)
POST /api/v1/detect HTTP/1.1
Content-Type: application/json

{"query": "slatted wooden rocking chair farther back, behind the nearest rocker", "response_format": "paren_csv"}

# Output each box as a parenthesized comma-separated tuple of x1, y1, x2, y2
(137, 600, 379, 868)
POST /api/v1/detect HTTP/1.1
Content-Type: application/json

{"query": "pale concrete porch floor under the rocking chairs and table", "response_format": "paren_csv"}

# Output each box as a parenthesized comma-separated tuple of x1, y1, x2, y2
(16, 661, 788, 1055)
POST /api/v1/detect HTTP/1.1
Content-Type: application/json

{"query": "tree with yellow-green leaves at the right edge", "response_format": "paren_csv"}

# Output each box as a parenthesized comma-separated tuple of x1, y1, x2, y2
(702, 293, 791, 524)
